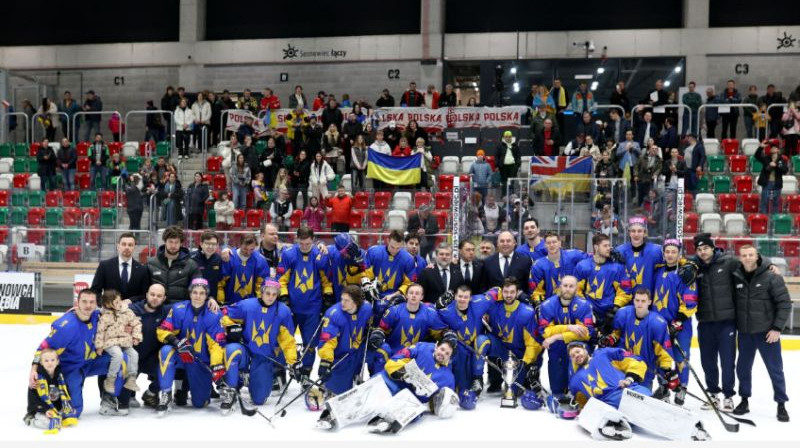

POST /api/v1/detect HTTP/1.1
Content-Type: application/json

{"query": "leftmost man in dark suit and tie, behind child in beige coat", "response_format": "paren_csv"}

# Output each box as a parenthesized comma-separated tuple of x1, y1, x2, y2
(91, 232, 150, 302)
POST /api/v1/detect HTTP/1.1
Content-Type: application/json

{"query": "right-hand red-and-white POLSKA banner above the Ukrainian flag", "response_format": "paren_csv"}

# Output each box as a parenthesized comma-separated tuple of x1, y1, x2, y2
(373, 106, 528, 132)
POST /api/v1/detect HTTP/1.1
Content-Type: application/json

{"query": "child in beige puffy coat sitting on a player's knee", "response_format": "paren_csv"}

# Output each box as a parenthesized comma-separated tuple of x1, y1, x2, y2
(94, 289, 142, 394)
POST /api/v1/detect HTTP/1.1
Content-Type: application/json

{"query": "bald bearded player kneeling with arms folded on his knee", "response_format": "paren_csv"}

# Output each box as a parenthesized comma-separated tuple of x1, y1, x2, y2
(538, 275, 595, 396)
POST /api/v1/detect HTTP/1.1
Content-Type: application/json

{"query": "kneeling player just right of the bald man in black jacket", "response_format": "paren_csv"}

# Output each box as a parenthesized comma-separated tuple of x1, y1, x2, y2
(156, 278, 225, 416)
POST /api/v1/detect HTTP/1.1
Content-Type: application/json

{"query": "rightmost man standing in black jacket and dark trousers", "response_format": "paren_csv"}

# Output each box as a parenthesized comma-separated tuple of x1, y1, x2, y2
(733, 245, 792, 422)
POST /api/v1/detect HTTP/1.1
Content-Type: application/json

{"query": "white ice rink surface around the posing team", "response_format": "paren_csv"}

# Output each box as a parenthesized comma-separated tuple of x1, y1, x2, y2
(0, 324, 800, 446)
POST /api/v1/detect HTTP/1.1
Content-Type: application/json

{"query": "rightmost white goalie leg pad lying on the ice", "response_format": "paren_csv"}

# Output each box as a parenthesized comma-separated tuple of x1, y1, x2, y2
(619, 389, 708, 440)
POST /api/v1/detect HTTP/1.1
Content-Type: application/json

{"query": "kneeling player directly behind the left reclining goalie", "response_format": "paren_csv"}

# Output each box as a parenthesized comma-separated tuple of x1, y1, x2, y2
(368, 283, 447, 372)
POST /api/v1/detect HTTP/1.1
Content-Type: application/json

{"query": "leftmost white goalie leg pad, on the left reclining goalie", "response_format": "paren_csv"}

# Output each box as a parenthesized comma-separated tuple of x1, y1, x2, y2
(325, 375, 392, 429)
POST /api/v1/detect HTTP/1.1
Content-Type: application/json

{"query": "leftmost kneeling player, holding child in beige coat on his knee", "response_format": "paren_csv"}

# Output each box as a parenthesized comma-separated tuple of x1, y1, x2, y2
(29, 289, 128, 418)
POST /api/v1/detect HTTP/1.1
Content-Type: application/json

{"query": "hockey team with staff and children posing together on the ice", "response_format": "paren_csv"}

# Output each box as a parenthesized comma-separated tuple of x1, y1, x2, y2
(25, 218, 789, 432)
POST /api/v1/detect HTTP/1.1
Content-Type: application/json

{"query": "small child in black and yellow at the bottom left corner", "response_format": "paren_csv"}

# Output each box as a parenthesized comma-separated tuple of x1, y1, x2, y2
(23, 348, 78, 434)
